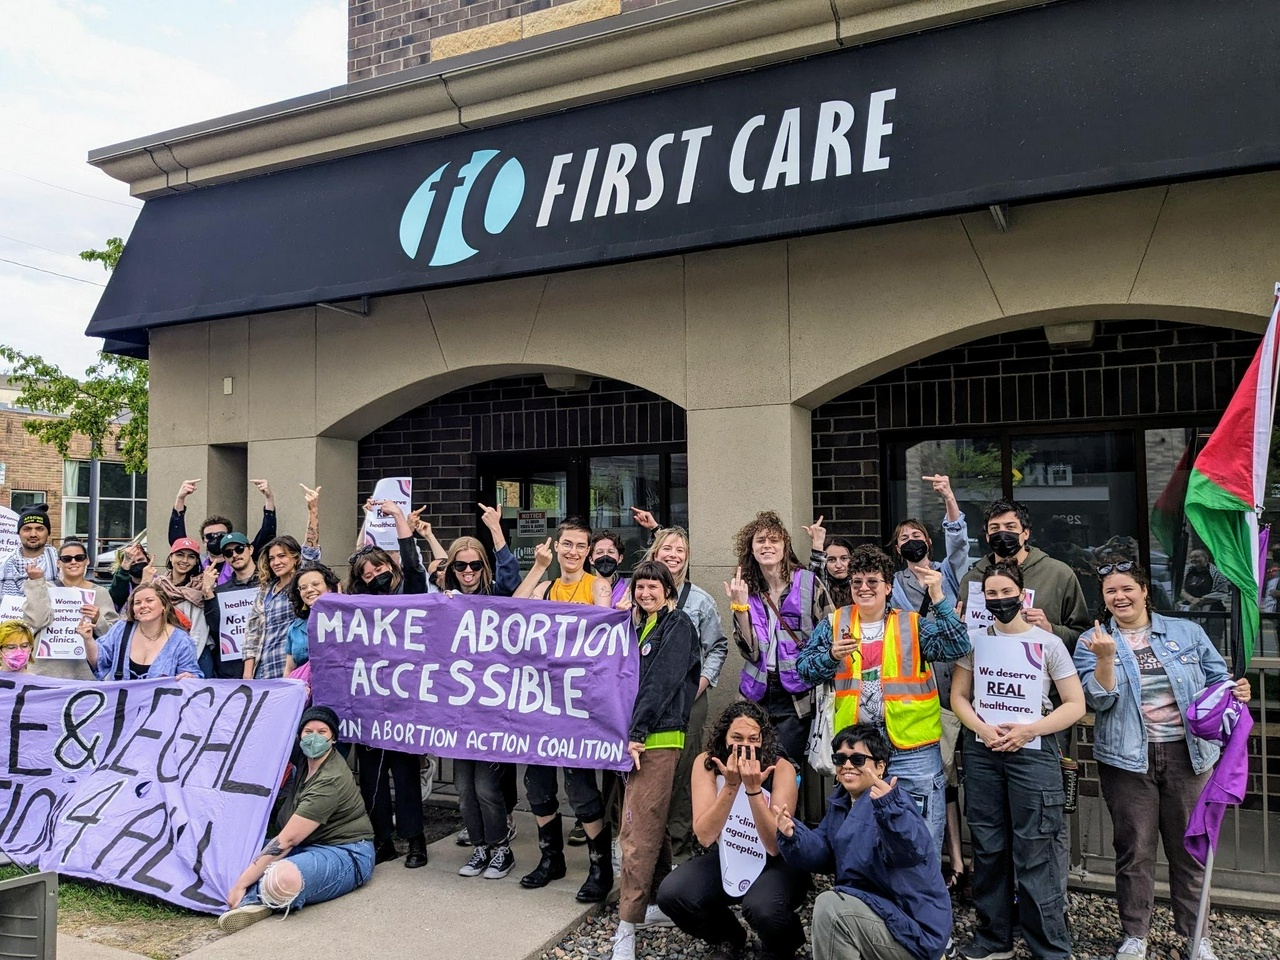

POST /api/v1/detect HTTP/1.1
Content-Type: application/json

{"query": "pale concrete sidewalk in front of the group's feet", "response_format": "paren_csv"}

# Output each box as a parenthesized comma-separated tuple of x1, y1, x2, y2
(58, 813, 594, 960)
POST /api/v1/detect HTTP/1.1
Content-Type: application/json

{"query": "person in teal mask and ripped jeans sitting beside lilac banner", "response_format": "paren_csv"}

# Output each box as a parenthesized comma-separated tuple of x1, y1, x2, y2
(218, 707, 374, 933)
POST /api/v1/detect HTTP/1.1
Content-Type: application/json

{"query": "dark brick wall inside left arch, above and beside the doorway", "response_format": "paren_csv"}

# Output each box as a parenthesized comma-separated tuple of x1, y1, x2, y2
(358, 376, 685, 545)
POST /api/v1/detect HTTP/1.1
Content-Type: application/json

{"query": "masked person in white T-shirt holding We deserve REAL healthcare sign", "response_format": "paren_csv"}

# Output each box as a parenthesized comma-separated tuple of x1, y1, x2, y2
(951, 563, 1084, 960)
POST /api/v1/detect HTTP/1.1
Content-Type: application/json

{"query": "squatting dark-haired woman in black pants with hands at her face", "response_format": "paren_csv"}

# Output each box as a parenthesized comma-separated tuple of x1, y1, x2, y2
(658, 700, 809, 960)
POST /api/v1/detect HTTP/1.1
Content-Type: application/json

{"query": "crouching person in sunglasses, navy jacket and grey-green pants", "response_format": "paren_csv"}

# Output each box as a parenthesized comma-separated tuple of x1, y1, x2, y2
(774, 727, 952, 960)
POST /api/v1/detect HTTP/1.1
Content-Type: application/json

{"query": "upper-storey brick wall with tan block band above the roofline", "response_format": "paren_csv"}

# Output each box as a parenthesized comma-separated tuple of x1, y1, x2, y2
(347, 0, 686, 82)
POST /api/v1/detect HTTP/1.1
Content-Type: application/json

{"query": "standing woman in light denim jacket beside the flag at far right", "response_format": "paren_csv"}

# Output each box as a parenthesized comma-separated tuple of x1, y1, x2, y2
(1075, 561, 1253, 960)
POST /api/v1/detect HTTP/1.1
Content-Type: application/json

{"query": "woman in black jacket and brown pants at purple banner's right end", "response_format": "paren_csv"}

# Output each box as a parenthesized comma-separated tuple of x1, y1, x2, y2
(613, 561, 700, 960)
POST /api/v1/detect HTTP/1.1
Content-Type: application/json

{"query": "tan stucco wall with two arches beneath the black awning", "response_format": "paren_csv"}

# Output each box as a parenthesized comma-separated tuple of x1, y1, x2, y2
(148, 173, 1280, 599)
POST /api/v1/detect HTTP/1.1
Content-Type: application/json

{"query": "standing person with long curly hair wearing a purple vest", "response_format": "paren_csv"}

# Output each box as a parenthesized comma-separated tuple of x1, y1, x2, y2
(724, 511, 831, 765)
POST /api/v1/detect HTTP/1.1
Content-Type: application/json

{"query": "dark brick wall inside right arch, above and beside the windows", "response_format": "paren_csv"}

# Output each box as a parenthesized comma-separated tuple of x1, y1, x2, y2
(813, 320, 1258, 541)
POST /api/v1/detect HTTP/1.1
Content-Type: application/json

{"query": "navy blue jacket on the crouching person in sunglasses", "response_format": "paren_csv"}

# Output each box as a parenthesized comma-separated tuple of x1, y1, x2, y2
(778, 787, 951, 960)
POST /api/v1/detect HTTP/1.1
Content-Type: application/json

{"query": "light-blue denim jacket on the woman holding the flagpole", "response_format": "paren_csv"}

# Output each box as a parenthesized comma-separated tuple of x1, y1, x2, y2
(1075, 613, 1230, 773)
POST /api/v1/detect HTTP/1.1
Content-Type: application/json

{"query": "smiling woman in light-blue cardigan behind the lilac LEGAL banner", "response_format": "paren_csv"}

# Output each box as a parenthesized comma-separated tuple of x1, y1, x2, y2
(76, 580, 205, 680)
